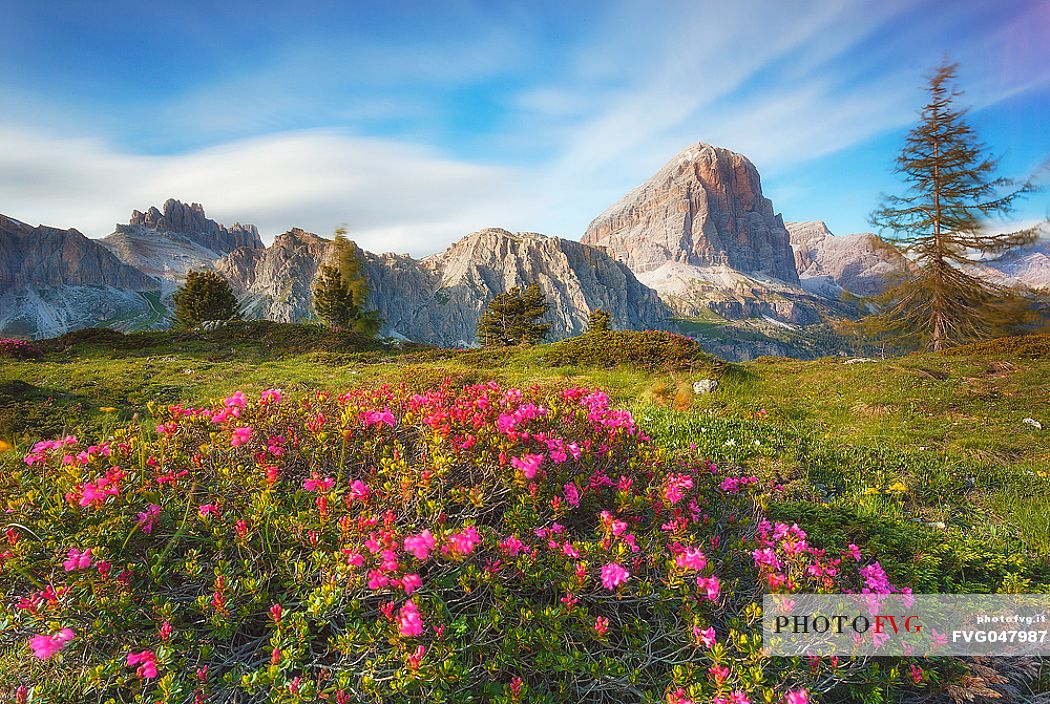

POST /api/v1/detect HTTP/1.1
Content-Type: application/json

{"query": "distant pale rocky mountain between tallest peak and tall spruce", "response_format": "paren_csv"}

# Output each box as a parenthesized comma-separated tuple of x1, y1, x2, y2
(786, 221, 906, 297)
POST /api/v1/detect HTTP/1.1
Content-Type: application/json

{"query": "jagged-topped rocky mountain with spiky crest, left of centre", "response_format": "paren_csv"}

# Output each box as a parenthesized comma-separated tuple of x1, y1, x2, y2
(102, 199, 264, 289)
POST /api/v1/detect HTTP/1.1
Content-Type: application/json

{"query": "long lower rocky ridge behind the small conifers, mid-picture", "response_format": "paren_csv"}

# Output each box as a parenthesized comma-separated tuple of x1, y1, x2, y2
(217, 229, 668, 346)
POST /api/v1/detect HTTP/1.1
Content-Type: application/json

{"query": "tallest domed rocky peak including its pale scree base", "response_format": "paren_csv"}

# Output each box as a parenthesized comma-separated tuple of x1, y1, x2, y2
(583, 143, 827, 332)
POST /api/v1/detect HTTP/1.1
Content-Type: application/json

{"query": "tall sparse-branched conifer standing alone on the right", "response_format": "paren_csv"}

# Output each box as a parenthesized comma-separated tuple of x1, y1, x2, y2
(864, 63, 1037, 350)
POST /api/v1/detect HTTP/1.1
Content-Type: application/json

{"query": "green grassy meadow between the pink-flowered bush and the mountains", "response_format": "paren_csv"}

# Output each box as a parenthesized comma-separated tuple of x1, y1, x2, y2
(6, 324, 1050, 591)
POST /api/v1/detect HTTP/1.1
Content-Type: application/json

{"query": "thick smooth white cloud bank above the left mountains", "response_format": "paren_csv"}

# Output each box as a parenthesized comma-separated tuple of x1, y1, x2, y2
(0, 127, 521, 254)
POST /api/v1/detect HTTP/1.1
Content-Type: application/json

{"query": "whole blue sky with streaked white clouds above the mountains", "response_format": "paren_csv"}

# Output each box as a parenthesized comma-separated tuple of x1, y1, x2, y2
(0, 0, 1050, 254)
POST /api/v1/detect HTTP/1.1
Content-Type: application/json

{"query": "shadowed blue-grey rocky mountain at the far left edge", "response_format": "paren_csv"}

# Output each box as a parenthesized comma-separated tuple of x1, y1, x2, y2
(0, 215, 161, 337)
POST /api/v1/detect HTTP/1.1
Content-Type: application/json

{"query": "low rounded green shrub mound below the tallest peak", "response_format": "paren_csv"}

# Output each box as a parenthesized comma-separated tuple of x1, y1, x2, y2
(545, 330, 720, 371)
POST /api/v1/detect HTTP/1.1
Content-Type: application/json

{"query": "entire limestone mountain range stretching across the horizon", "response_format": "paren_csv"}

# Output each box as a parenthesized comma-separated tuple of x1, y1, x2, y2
(0, 144, 1050, 353)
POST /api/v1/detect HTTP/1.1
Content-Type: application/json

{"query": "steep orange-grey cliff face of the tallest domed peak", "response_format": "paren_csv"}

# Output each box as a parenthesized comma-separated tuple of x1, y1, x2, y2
(583, 143, 798, 284)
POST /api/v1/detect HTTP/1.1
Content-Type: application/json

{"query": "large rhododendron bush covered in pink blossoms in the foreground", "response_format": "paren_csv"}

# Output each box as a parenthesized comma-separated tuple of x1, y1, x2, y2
(6, 384, 928, 704)
